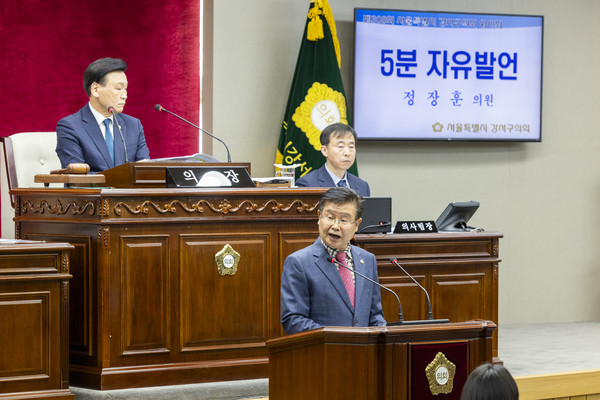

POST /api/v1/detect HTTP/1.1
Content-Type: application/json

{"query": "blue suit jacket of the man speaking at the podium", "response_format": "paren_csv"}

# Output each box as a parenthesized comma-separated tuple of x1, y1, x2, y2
(281, 239, 386, 333)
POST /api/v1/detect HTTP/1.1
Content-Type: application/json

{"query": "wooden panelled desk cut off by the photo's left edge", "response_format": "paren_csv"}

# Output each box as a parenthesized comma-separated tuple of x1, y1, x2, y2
(0, 239, 75, 399)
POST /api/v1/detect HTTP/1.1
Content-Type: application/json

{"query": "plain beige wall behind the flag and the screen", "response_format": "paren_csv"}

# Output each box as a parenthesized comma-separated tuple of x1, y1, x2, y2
(214, 0, 600, 323)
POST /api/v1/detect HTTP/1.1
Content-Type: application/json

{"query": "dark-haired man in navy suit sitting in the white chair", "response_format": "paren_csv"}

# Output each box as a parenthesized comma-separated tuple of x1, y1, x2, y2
(56, 58, 150, 173)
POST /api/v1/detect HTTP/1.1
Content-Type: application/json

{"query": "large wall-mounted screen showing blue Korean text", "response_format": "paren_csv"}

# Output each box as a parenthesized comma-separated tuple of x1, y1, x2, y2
(354, 8, 543, 142)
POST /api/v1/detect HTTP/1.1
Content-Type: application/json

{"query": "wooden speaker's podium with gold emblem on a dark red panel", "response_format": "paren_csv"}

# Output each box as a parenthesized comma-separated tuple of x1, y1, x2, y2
(267, 320, 496, 400)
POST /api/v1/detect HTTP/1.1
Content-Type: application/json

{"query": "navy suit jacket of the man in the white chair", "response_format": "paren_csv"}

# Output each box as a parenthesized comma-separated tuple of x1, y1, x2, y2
(56, 104, 150, 173)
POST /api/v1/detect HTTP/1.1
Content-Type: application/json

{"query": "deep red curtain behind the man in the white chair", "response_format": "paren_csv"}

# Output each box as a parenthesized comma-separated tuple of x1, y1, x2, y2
(0, 0, 200, 234)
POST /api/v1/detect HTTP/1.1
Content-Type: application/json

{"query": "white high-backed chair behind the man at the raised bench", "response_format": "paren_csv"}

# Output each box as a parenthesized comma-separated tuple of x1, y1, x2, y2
(0, 132, 62, 238)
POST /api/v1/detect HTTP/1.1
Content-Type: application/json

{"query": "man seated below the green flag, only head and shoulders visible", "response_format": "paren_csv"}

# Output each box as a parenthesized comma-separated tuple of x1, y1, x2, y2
(296, 123, 371, 197)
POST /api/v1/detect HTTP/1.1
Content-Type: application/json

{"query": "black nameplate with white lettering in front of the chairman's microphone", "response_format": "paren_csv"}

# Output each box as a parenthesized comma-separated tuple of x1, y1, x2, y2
(165, 166, 254, 188)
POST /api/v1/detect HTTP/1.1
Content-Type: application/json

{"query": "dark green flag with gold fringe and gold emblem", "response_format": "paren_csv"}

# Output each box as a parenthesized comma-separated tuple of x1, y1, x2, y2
(275, 0, 358, 178)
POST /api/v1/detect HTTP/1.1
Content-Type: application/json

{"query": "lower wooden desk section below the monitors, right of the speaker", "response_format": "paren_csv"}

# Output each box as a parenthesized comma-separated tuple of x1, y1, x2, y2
(355, 232, 502, 358)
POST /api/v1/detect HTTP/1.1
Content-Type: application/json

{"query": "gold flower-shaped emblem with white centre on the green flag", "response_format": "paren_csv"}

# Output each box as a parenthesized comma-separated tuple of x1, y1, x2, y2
(292, 82, 348, 151)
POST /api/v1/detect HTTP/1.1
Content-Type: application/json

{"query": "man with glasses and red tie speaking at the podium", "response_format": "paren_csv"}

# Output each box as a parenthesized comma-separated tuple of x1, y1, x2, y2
(281, 187, 386, 333)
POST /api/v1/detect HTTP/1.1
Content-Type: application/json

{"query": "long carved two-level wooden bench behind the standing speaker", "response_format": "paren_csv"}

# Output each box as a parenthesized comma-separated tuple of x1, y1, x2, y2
(11, 188, 501, 389)
